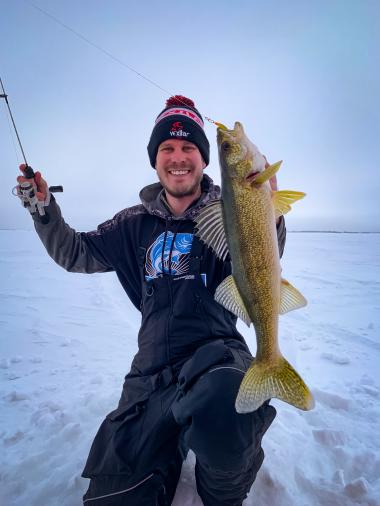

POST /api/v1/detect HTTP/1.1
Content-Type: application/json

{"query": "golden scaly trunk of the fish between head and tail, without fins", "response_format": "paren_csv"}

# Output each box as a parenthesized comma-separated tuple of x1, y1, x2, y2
(223, 178, 281, 361)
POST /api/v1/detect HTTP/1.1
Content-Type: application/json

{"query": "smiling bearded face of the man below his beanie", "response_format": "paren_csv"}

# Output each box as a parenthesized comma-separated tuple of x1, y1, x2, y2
(156, 139, 206, 198)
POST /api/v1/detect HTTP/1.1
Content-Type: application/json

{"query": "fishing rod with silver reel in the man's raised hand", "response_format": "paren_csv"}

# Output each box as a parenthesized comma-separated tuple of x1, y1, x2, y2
(0, 77, 63, 223)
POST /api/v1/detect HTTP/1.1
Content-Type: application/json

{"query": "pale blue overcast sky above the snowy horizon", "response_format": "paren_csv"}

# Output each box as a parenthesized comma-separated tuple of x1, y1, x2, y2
(0, 0, 380, 232)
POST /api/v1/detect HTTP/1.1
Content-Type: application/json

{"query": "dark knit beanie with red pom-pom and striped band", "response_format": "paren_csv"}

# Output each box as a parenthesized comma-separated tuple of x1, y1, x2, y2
(148, 95, 210, 168)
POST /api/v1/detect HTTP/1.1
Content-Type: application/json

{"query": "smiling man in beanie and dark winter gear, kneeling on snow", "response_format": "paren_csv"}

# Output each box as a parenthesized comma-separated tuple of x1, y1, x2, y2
(18, 96, 285, 506)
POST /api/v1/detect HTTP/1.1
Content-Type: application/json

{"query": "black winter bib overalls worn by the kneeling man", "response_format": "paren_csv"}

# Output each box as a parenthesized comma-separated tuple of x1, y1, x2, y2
(83, 232, 275, 506)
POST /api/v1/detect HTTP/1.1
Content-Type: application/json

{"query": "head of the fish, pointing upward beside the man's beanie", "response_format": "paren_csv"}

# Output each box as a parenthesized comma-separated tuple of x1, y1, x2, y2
(217, 121, 266, 183)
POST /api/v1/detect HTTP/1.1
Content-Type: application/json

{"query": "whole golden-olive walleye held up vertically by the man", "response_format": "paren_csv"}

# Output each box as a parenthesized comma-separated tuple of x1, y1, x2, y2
(196, 122, 314, 413)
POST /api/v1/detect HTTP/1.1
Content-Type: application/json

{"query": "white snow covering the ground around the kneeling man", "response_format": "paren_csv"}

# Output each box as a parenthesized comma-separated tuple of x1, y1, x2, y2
(0, 231, 380, 506)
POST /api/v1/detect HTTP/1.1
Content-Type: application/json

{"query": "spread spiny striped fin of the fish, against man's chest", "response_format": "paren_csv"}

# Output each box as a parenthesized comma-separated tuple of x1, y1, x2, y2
(195, 200, 228, 260)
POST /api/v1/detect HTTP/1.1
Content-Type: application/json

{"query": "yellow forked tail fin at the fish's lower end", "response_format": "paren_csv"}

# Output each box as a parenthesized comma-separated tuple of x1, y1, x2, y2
(235, 356, 314, 413)
